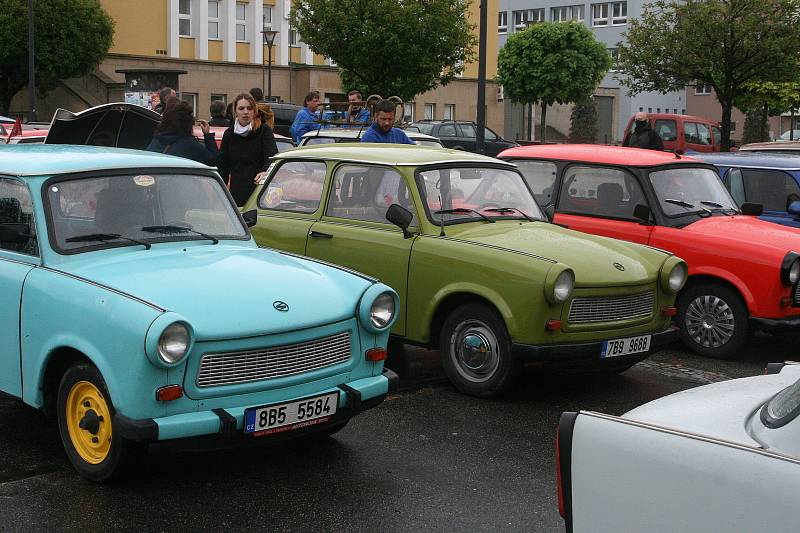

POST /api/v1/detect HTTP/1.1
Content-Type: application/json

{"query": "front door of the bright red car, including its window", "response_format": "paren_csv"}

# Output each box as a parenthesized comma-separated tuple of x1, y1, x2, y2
(554, 164, 653, 244)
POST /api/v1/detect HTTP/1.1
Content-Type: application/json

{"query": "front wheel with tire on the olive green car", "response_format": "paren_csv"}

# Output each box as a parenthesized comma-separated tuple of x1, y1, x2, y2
(440, 304, 522, 398)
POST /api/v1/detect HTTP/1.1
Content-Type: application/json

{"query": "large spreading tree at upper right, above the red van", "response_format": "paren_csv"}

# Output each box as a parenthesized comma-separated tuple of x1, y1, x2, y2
(618, 0, 800, 150)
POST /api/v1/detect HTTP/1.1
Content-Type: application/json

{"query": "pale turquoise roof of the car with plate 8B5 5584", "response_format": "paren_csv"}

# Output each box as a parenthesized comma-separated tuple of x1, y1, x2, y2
(0, 144, 209, 176)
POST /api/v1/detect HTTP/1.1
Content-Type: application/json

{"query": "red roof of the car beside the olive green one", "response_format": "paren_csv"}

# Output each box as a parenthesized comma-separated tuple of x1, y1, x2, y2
(498, 144, 699, 167)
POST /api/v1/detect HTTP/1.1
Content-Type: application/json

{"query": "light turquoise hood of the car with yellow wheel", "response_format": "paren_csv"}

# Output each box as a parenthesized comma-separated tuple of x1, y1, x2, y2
(62, 243, 373, 340)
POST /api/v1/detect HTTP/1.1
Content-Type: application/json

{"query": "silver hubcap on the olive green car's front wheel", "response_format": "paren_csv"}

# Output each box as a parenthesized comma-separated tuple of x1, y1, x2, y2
(450, 320, 500, 382)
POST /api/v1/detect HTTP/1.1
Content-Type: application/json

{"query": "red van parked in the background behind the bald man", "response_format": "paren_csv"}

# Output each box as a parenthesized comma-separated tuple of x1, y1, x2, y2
(623, 113, 722, 152)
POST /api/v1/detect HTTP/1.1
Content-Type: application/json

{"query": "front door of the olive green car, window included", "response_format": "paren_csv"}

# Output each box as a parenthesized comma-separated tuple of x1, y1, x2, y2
(306, 163, 418, 335)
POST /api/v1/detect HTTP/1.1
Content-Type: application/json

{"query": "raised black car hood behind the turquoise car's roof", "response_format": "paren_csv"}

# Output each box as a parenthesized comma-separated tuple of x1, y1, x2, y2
(44, 103, 161, 150)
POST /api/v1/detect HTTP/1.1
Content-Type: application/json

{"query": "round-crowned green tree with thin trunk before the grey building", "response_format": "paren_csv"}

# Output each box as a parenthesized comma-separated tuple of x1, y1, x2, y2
(497, 22, 611, 141)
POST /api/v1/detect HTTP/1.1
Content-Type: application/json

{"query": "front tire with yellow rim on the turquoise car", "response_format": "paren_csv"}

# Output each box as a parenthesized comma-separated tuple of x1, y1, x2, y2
(58, 363, 141, 483)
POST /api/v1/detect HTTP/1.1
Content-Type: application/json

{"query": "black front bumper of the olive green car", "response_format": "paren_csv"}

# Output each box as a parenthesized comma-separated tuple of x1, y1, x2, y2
(512, 326, 678, 367)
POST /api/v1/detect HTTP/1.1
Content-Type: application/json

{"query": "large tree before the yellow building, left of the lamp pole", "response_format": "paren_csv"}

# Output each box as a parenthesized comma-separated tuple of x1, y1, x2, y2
(292, 0, 476, 100)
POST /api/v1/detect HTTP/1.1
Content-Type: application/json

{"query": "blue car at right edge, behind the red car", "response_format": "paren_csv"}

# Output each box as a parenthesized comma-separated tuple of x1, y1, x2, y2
(693, 151, 800, 228)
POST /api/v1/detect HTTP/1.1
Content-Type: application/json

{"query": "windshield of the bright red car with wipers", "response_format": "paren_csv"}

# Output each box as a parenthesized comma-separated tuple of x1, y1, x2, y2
(650, 167, 738, 217)
